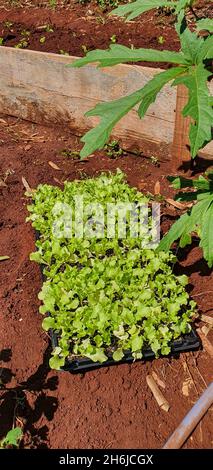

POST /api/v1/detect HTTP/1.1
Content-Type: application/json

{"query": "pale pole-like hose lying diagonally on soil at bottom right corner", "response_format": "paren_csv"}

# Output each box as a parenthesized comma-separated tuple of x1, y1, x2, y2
(163, 382, 213, 449)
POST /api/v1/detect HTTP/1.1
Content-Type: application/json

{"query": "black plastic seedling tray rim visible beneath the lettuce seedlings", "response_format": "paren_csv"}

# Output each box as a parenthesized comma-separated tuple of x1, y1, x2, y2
(50, 329, 201, 373)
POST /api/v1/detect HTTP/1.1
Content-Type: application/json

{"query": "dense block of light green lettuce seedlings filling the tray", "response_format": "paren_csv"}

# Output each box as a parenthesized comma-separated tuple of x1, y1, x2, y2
(28, 171, 195, 369)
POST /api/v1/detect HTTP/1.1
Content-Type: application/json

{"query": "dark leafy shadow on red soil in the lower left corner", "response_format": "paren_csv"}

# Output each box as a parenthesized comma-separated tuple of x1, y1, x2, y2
(0, 346, 58, 448)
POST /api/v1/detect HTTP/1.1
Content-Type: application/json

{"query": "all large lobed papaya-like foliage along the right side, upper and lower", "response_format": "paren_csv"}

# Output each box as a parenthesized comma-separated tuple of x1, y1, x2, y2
(68, 0, 213, 267)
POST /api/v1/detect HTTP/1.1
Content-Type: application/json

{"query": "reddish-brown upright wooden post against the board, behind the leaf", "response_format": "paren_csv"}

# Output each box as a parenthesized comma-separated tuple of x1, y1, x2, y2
(172, 85, 191, 171)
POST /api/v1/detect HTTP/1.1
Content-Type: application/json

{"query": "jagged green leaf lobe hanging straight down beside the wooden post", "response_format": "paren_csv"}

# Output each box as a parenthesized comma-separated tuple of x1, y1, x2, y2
(173, 63, 213, 158)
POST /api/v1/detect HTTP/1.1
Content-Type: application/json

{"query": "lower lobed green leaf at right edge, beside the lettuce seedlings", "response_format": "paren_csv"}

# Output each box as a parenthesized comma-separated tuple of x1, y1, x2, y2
(157, 172, 213, 268)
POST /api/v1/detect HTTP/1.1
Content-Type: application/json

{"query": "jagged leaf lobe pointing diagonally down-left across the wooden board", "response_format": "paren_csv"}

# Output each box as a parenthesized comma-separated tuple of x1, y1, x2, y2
(80, 67, 185, 158)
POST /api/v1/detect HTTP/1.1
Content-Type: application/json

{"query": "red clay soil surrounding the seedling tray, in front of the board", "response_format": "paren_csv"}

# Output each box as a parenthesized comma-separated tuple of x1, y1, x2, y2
(0, 116, 213, 449)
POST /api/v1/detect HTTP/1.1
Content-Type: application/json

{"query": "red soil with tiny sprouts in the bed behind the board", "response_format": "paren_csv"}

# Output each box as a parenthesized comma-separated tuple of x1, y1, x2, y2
(0, 0, 213, 68)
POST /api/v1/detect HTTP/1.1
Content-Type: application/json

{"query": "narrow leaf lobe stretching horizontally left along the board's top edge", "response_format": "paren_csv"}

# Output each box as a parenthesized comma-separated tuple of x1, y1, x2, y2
(71, 44, 190, 67)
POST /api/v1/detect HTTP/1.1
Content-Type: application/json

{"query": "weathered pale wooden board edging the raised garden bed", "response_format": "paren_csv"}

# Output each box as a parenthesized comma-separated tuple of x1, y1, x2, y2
(0, 47, 213, 157)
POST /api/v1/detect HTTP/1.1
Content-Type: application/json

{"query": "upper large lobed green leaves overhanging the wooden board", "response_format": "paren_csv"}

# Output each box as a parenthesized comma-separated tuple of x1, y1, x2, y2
(71, 0, 213, 158)
